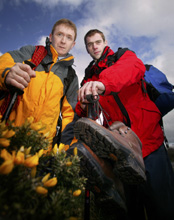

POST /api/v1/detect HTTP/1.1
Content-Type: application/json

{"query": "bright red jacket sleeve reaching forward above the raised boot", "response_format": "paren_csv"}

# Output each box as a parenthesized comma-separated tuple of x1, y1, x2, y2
(99, 50, 145, 95)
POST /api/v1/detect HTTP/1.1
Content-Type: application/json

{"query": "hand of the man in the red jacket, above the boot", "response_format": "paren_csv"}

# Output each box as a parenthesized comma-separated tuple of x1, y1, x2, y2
(78, 81, 105, 103)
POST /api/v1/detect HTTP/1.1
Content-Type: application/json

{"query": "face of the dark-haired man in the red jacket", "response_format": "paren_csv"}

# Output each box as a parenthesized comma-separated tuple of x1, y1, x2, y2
(86, 33, 107, 60)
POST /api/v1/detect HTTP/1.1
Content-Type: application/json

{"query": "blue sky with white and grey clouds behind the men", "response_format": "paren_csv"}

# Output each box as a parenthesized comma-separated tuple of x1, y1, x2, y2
(0, 0, 174, 143)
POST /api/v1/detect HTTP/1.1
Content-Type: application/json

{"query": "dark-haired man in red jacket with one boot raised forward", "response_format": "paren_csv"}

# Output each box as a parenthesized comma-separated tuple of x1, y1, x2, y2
(75, 29, 174, 219)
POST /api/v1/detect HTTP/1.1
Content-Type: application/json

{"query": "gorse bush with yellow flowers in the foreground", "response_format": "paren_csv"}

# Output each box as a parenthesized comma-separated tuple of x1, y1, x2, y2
(0, 117, 86, 220)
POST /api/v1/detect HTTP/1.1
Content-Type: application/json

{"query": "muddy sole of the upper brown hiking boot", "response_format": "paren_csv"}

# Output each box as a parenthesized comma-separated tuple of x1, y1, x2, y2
(74, 118, 146, 184)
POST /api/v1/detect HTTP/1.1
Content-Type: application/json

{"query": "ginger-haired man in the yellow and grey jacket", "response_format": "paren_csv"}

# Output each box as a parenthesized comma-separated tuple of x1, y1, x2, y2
(0, 19, 78, 145)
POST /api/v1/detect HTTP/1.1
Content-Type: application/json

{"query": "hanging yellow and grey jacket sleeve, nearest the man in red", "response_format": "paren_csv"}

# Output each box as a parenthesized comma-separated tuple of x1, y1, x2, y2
(60, 73, 79, 145)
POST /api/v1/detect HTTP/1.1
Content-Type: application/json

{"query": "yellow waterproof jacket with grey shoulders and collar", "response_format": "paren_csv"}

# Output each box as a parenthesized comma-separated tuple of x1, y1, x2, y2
(0, 45, 79, 144)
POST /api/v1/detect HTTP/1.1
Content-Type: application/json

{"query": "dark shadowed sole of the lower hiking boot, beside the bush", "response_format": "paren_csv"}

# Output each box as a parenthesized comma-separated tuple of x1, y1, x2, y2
(67, 142, 126, 212)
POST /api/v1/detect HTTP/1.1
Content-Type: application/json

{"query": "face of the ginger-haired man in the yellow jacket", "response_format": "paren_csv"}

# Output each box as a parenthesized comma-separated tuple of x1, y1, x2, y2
(50, 24, 75, 57)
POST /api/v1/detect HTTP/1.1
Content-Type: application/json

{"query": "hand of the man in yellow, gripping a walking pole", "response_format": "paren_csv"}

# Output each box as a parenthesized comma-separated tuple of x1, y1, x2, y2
(5, 63, 36, 90)
